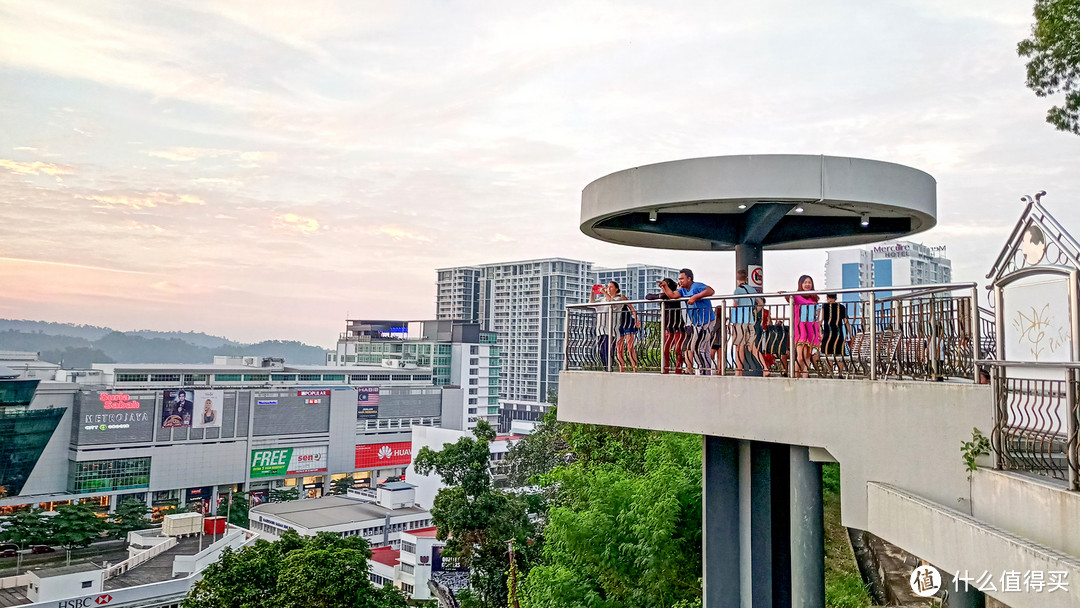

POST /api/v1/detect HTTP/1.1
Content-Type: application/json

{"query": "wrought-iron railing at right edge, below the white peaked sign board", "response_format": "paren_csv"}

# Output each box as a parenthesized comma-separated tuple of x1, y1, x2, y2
(978, 361, 1080, 490)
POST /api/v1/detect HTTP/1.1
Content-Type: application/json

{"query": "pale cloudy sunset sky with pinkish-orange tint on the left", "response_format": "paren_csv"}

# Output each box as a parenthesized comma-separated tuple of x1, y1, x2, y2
(0, 0, 1080, 346)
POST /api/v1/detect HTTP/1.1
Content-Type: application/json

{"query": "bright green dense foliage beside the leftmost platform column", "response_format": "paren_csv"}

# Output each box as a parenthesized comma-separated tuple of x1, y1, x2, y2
(519, 431, 701, 608)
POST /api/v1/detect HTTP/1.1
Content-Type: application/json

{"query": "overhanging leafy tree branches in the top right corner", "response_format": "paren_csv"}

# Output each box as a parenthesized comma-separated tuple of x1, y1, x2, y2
(1016, 0, 1080, 135)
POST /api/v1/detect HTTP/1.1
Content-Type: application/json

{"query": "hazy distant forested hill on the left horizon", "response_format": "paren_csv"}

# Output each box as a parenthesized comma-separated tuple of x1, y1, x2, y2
(0, 319, 326, 369)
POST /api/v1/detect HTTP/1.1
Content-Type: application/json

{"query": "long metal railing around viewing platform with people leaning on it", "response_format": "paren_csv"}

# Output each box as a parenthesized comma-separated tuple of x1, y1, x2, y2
(564, 283, 995, 381)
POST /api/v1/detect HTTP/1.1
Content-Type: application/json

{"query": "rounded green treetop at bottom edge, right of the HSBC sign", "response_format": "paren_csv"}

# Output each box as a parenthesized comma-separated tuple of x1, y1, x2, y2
(184, 530, 408, 608)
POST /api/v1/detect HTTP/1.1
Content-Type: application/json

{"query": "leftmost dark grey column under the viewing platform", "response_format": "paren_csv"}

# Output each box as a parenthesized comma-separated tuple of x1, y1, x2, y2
(701, 435, 741, 608)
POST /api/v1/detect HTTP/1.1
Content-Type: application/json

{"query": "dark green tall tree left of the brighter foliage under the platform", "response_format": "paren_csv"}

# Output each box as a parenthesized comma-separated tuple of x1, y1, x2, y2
(414, 420, 539, 608)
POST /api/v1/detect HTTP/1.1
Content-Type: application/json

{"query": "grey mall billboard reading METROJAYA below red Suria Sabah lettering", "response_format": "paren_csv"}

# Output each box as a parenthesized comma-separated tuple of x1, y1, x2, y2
(72, 391, 156, 445)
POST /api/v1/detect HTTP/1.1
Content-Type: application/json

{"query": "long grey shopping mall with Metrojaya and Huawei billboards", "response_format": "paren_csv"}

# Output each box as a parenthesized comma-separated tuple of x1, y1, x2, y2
(0, 352, 464, 513)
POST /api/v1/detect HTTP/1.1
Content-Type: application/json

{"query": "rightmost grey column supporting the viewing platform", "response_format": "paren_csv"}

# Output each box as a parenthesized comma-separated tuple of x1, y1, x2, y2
(788, 446, 825, 608)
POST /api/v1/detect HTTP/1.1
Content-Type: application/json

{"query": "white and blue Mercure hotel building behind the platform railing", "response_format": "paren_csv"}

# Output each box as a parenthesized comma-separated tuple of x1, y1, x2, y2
(825, 241, 953, 301)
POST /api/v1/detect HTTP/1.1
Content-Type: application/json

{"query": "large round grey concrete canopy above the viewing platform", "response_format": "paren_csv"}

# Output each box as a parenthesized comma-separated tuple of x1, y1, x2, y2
(581, 154, 937, 251)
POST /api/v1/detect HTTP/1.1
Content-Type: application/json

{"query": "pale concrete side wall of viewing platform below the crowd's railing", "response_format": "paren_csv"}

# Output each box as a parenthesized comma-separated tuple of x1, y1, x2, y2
(558, 371, 993, 531)
